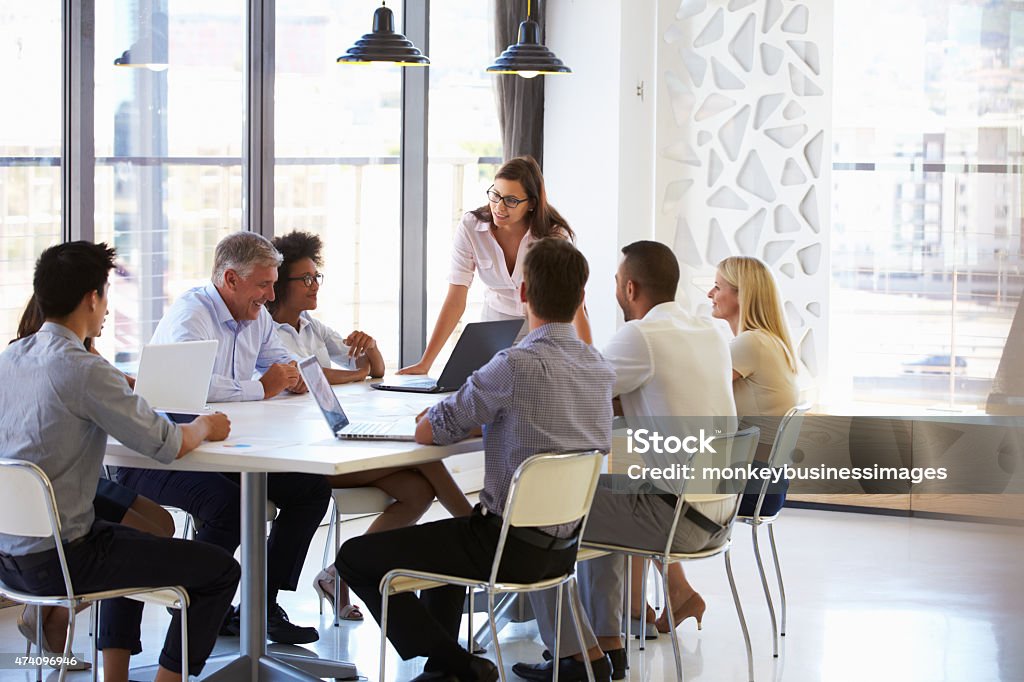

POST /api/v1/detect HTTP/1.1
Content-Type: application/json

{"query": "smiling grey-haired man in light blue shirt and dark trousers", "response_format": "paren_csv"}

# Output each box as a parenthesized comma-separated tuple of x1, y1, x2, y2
(117, 232, 331, 644)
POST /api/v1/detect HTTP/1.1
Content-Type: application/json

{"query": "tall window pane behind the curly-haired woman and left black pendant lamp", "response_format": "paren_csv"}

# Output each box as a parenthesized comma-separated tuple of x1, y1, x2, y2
(274, 0, 402, 365)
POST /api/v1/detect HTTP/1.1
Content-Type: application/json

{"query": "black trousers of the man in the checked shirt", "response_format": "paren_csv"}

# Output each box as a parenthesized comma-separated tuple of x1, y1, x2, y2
(336, 503, 577, 659)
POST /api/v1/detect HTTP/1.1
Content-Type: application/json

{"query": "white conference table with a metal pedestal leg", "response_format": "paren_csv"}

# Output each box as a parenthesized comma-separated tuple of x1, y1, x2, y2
(104, 382, 481, 682)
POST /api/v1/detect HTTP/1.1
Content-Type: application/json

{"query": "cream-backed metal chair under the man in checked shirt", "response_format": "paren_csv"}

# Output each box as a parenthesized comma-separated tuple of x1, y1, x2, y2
(378, 451, 604, 682)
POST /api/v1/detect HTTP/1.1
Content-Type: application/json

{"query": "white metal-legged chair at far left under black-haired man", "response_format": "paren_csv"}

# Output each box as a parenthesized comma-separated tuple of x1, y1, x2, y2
(0, 459, 188, 682)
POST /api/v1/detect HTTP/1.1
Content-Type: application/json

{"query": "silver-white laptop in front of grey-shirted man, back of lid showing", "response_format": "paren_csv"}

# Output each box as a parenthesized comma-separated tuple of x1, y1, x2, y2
(135, 341, 217, 414)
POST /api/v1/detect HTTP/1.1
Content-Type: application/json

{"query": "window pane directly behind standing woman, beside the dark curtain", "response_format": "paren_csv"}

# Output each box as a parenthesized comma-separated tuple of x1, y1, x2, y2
(427, 0, 502, 360)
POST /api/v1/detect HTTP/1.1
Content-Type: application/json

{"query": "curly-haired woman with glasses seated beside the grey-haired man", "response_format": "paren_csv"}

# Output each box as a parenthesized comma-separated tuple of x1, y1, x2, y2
(267, 231, 472, 621)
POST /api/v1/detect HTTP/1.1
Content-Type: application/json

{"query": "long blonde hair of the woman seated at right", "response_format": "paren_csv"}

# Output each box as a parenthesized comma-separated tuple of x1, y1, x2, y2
(718, 256, 797, 373)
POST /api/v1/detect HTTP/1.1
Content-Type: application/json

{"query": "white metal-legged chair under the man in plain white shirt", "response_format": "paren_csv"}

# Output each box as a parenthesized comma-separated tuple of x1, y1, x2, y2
(581, 427, 760, 682)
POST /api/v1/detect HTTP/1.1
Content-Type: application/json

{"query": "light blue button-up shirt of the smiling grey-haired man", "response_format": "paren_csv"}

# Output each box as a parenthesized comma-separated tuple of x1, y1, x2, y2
(151, 283, 296, 402)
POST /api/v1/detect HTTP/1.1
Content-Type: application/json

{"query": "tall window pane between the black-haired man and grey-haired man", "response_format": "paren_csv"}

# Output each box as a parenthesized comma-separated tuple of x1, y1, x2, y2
(94, 0, 245, 363)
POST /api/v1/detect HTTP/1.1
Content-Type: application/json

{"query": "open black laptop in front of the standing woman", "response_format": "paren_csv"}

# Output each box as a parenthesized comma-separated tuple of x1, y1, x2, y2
(372, 319, 523, 393)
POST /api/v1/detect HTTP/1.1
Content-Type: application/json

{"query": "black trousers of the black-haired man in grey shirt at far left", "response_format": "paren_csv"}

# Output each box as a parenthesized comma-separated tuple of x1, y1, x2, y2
(0, 520, 242, 675)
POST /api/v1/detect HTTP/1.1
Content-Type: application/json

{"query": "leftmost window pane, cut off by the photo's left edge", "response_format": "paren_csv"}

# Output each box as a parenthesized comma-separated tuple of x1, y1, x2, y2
(0, 0, 61, 339)
